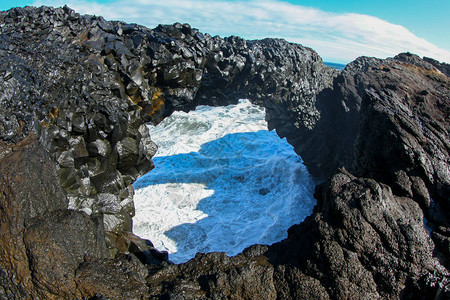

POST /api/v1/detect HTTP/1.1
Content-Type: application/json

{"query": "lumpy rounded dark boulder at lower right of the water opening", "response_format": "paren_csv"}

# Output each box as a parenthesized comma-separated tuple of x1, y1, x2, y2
(268, 170, 443, 299)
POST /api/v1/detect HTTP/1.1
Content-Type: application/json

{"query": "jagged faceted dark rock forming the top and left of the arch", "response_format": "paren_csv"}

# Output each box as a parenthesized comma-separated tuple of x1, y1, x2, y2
(1, 4, 336, 236)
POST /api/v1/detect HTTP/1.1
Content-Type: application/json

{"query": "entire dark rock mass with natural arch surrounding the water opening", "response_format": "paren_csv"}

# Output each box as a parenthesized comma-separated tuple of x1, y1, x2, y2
(0, 7, 450, 299)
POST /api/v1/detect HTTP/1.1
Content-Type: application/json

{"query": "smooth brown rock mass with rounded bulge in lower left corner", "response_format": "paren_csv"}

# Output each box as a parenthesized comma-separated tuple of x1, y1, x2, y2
(0, 134, 106, 299)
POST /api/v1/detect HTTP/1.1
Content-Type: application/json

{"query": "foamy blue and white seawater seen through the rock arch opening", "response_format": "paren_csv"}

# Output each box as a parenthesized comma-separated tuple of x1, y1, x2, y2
(133, 100, 315, 263)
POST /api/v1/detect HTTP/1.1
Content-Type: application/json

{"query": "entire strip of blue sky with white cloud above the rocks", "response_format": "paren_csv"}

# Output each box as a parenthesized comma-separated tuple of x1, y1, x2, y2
(0, 0, 450, 63)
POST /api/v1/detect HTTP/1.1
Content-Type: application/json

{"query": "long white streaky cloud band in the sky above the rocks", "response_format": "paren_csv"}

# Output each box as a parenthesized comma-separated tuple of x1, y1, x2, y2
(34, 0, 450, 62)
